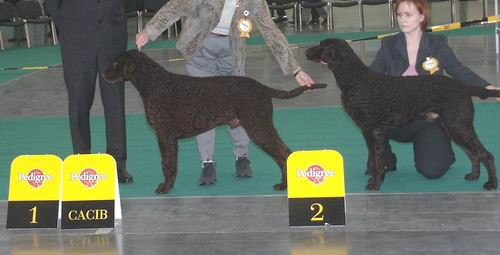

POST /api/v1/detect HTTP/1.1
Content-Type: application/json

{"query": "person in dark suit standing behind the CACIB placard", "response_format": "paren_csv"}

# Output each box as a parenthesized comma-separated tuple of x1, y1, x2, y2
(45, 0, 133, 183)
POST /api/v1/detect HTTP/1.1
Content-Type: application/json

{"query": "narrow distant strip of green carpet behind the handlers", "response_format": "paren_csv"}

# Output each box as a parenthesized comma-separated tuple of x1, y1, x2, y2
(0, 25, 495, 85)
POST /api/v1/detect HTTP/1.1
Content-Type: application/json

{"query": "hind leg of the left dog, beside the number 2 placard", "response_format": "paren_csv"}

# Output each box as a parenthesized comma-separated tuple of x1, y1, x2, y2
(240, 118, 292, 190)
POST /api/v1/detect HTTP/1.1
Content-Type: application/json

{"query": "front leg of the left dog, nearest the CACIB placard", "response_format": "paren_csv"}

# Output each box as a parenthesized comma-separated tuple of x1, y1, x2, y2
(156, 137, 182, 194)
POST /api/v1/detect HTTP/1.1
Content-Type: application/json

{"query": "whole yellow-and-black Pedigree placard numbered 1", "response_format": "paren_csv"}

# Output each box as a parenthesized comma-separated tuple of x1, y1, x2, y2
(7, 155, 62, 228)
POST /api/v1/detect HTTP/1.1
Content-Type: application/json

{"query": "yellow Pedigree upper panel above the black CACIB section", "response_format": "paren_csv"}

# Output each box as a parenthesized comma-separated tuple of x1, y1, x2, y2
(62, 154, 116, 201)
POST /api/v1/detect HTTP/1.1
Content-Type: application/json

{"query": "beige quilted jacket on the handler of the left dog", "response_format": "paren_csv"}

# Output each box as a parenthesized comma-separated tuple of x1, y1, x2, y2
(145, 0, 300, 75)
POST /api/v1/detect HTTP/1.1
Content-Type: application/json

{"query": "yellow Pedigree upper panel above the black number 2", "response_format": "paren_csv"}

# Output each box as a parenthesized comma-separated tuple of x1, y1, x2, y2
(287, 150, 345, 198)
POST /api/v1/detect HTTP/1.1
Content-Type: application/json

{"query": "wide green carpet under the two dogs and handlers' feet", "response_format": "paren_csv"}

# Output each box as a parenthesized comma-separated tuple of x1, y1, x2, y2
(0, 103, 500, 200)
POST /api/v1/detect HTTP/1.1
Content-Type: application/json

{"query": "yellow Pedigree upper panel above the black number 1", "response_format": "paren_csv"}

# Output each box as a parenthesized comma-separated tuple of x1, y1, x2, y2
(9, 155, 62, 201)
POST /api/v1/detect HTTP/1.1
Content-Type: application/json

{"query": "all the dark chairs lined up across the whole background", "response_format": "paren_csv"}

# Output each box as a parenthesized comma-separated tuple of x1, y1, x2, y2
(0, 0, 487, 50)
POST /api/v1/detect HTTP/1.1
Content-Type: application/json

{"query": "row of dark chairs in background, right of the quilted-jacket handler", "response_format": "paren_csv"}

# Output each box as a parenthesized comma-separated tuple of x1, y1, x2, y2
(268, 0, 488, 31)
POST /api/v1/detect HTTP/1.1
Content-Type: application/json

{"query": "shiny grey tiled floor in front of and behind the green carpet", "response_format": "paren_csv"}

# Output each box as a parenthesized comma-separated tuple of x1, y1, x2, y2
(0, 1, 500, 255)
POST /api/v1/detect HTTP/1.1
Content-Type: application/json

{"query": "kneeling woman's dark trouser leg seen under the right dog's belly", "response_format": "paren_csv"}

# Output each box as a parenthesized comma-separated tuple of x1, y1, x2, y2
(388, 119, 455, 179)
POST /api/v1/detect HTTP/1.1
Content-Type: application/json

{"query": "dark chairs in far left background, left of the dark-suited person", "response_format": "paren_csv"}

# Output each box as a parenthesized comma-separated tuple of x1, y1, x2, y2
(0, 0, 58, 50)
